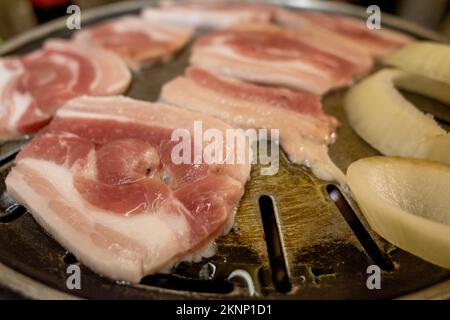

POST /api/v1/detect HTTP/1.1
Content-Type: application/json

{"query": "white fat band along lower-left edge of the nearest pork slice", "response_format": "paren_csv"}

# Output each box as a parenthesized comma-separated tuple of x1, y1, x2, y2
(6, 159, 192, 282)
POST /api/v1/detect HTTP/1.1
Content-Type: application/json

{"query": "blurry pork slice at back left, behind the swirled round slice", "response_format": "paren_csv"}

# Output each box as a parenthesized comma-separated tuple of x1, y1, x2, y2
(74, 16, 193, 69)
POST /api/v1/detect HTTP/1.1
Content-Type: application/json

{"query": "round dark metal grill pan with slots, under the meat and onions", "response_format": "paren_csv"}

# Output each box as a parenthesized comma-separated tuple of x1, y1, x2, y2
(0, 1, 450, 299)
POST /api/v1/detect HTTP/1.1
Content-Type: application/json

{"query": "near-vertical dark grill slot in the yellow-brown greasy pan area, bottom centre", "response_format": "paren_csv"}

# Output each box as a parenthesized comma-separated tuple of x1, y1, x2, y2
(259, 195, 292, 293)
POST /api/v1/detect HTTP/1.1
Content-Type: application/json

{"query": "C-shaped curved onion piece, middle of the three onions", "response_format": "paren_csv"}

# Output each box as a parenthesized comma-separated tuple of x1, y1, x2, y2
(345, 69, 450, 164)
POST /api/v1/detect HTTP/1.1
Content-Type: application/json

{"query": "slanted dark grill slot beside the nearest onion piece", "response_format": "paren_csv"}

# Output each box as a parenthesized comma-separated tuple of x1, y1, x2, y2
(327, 184, 394, 271)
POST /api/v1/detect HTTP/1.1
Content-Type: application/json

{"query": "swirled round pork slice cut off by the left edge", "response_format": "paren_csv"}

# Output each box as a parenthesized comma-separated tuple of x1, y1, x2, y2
(0, 40, 131, 140)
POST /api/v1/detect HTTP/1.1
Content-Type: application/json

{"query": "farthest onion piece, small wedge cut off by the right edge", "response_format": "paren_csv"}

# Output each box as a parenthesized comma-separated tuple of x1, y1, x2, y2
(386, 41, 450, 85)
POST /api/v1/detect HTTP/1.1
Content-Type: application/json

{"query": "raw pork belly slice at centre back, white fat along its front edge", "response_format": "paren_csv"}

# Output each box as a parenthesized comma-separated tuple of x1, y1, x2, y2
(190, 23, 361, 94)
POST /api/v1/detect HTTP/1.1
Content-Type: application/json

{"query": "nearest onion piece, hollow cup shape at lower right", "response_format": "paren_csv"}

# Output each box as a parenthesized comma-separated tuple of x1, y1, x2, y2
(347, 157, 450, 268)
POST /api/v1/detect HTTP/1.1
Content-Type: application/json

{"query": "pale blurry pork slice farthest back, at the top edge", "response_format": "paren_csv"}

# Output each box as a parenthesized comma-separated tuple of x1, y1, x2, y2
(142, 1, 275, 29)
